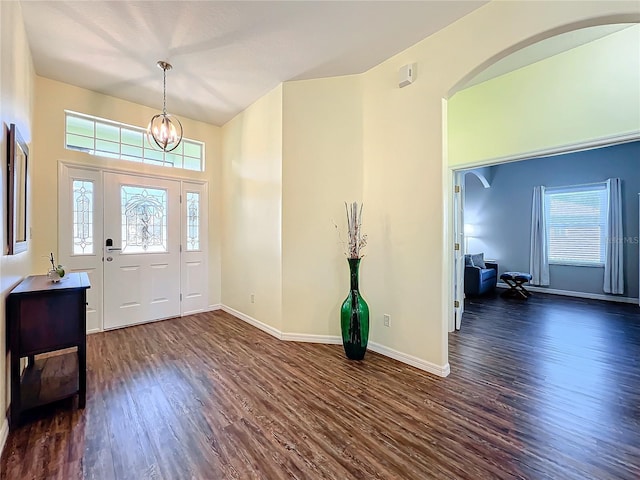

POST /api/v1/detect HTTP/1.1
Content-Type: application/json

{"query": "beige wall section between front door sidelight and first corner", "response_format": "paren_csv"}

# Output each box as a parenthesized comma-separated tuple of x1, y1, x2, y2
(222, 85, 282, 330)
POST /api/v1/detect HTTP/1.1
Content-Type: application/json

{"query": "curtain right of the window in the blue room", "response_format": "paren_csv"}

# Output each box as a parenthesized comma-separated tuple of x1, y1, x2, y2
(604, 178, 624, 295)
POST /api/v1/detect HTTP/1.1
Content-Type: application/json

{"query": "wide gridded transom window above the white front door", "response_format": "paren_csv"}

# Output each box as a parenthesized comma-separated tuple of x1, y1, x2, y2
(65, 111, 204, 172)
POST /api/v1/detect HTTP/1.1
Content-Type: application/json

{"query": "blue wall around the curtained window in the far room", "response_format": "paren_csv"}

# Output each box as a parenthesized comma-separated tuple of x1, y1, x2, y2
(465, 142, 640, 298)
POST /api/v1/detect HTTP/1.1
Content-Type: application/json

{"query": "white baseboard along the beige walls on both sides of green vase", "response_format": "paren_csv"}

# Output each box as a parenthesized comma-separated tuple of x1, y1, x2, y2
(221, 305, 450, 377)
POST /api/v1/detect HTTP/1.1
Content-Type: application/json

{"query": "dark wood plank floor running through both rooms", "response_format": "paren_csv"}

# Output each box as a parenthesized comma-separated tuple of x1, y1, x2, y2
(0, 295, 640, 480)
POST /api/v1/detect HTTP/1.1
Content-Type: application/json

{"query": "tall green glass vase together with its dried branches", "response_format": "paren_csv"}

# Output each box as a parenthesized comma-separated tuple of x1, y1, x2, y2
(336, 202, 369, 360)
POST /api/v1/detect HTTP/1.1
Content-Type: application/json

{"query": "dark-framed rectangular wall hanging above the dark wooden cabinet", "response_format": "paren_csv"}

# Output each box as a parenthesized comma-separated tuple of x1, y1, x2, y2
(7, 123, 29, 255)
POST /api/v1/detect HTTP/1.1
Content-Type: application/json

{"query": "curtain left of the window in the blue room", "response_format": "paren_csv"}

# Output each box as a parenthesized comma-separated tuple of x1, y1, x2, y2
(529, 186, 549, 286)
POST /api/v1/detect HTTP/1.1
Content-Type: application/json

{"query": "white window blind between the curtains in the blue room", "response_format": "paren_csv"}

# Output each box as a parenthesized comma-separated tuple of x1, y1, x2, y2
(545, 183, 607, 265)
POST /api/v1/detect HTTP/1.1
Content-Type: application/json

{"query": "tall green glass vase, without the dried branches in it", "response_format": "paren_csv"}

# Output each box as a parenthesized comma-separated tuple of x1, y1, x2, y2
(340, 258, 369, 360)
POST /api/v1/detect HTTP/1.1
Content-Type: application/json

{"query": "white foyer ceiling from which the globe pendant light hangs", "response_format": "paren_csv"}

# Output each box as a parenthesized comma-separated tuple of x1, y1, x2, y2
(21, 0, 487, 125)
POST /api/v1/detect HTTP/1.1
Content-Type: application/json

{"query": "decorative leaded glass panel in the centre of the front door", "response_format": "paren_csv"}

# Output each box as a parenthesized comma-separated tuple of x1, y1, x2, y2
(120, 185, 167, 253)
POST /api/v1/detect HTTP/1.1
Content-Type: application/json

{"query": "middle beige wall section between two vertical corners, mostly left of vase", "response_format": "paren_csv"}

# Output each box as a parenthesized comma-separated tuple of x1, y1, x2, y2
(282, 75, 362, 335)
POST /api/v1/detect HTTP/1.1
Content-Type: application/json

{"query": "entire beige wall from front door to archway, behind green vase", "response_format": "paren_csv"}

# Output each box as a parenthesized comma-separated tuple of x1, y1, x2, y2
(222, 2, 638, 374)
